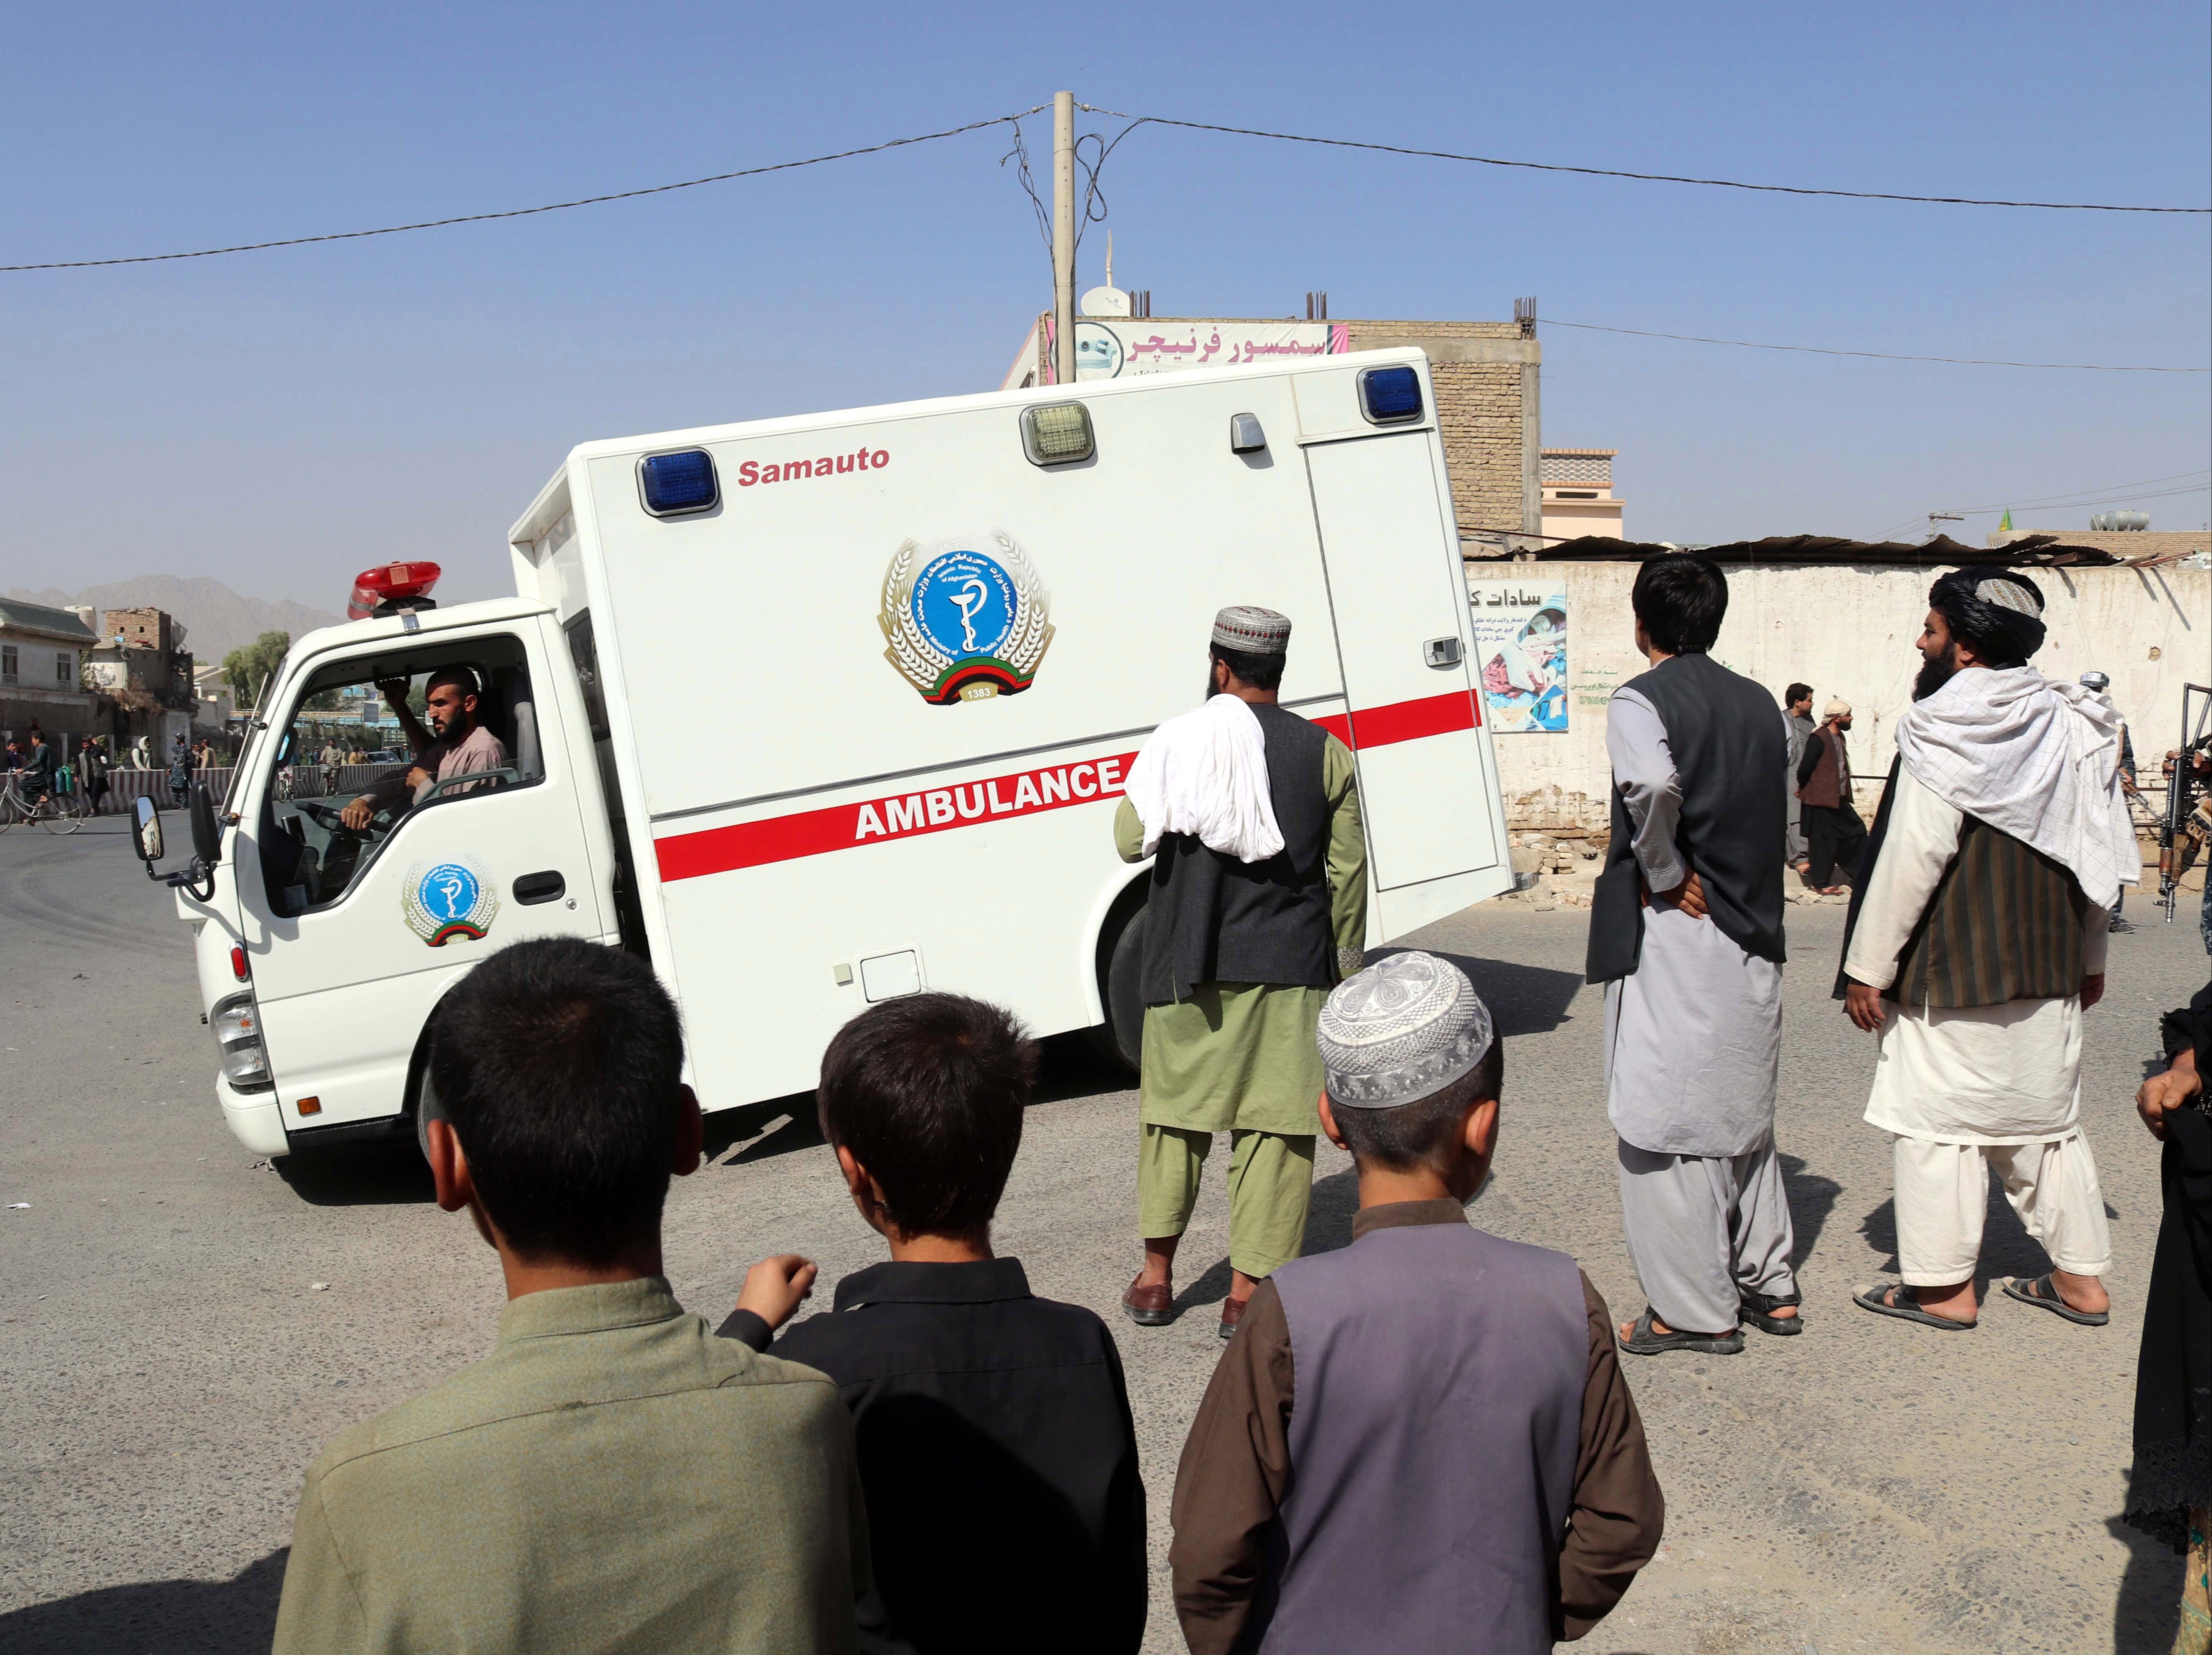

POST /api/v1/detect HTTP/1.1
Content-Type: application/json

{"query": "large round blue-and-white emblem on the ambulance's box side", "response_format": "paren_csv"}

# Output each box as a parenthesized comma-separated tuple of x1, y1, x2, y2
(876, 529, 1053, 706)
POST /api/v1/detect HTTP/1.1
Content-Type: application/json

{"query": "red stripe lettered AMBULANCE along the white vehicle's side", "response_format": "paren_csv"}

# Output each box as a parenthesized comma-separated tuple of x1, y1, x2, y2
(652, 690, 1480, 881)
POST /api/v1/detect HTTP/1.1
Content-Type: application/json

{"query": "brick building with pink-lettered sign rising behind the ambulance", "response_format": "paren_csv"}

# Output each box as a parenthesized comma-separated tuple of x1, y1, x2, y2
(1002, 303, 1544, 558)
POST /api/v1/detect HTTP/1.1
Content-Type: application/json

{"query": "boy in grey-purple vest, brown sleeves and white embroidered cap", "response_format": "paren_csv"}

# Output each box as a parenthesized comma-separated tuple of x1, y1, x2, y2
(1168, 954, 1665, 1655)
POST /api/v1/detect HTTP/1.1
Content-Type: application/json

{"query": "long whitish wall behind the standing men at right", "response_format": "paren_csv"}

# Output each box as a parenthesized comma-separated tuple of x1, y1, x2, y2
(1469, 562, 2212, 830)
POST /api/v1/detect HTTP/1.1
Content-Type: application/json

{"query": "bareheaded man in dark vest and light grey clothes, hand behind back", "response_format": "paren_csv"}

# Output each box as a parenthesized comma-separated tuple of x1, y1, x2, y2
(1588, 553, 1800, 1356)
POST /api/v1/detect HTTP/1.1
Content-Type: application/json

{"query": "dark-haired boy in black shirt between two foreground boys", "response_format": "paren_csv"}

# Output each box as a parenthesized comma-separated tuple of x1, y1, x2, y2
(721, 994, 1146, 1655)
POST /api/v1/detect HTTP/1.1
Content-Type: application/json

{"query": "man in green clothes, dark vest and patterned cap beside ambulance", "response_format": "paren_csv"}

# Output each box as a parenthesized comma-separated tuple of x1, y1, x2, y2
(1115, 604, 1367, 1339)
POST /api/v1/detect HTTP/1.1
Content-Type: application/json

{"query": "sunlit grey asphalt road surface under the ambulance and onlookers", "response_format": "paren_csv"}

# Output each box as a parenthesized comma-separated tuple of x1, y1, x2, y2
(0, 821, 2207, 1655)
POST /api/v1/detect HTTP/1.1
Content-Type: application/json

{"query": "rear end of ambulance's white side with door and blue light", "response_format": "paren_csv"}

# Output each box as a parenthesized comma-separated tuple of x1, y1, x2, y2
(1296, 370, 1513, 945)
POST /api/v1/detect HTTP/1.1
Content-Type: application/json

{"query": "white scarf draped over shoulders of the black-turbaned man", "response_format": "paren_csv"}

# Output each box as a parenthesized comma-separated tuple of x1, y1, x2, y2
(1898, 666, 2143, 909)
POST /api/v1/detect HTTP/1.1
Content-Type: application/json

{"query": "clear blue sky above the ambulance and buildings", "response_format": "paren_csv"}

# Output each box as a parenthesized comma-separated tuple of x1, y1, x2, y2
(0, 0, 2212, 606)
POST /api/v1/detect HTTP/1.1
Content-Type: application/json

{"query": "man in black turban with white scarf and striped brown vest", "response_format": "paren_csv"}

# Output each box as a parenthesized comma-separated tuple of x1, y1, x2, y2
(1836, 569, 2141, 1332)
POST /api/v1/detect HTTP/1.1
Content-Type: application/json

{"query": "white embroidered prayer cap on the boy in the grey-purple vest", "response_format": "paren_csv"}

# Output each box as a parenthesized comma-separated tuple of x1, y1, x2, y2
(1316, 949, 1495, 1109)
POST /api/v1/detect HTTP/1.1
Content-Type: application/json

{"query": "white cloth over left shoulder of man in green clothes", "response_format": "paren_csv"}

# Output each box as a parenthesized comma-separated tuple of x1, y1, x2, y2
(1121, 695, 1283, 863)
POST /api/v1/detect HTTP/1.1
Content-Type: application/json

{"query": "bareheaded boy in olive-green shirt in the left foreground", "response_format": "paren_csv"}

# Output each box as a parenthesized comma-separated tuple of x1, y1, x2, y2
(277, 938, 867, 1655)
